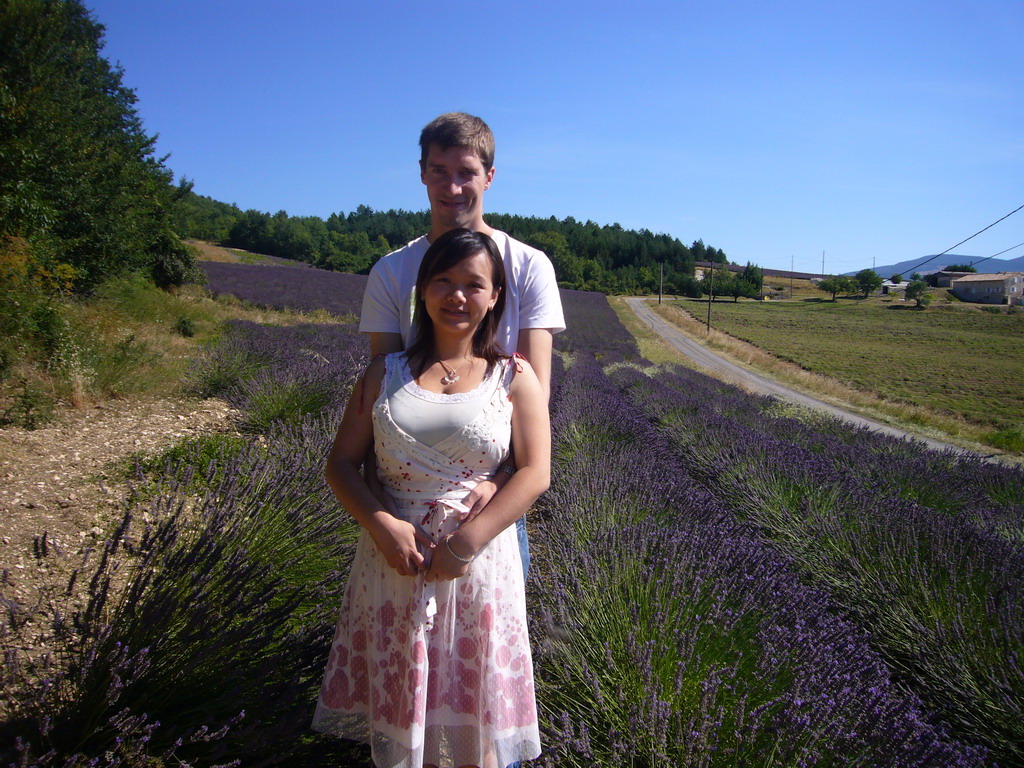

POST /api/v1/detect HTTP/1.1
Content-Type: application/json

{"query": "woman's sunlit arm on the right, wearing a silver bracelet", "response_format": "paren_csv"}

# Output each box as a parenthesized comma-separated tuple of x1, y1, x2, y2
(427, 360, 551, 581)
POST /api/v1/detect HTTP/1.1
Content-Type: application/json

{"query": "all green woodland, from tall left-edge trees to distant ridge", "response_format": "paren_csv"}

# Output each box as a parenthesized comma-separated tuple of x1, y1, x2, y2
(0, 0, 746, 301)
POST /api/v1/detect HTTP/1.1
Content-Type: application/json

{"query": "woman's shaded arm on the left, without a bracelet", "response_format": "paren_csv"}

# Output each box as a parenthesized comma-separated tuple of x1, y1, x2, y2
(324, 359, 433, 575)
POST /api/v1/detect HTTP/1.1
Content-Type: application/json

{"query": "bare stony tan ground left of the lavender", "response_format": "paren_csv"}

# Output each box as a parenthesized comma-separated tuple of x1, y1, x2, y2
(0, 399, 233, 600)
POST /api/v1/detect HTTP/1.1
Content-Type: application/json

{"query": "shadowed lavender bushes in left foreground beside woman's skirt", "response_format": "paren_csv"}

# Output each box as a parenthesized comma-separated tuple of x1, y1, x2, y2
(7, 418, 356, 765)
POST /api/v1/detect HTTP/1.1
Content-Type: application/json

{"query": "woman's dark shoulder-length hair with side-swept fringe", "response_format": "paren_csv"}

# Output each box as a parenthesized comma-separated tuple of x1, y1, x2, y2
(406, 228, 508, 376)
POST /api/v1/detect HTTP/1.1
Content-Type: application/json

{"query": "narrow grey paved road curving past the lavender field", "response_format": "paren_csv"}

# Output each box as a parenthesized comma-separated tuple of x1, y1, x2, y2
(626, 298, 971, 453)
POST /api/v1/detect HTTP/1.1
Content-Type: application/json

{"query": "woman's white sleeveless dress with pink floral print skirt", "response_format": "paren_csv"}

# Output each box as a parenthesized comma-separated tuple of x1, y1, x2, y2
(313, 352, 541, 768)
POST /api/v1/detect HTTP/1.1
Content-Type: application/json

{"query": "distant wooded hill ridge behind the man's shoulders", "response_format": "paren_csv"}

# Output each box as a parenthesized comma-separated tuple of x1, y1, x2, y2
(176, 193, 746, 296)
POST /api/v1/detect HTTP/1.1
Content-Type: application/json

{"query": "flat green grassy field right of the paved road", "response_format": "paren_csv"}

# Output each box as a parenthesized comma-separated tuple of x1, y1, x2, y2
(679, 299, 1024, 430)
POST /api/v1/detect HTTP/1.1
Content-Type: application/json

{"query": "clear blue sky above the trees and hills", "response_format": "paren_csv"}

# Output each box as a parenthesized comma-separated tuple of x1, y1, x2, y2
(85, 0, 1024, 272)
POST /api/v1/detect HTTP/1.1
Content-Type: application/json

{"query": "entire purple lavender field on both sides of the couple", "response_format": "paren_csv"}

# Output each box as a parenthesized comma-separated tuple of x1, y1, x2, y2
(0, 264, 1024, 768)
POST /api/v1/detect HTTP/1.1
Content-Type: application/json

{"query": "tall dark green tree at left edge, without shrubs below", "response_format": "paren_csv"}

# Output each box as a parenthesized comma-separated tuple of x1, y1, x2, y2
(0, 0, 196, 289)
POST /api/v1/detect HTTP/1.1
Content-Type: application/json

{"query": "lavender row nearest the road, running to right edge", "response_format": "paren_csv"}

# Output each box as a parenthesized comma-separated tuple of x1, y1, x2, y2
(614, 370, 1024, 765)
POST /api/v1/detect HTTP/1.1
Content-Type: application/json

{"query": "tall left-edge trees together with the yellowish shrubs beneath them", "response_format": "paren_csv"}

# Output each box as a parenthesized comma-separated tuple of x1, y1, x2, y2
(0, 0, 202, 403)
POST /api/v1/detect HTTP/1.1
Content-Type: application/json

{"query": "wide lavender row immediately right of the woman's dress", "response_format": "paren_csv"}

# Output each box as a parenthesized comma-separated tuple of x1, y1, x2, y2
(530, 359, 984, 766)
